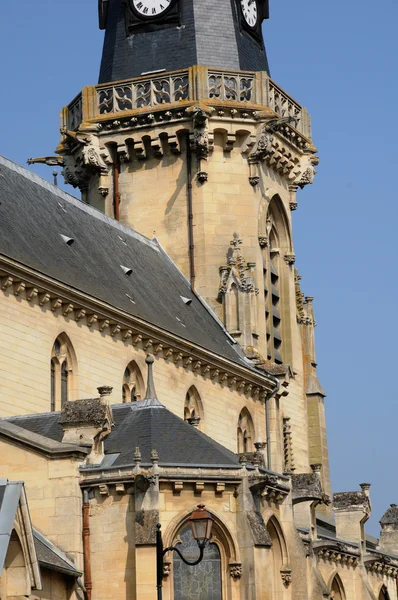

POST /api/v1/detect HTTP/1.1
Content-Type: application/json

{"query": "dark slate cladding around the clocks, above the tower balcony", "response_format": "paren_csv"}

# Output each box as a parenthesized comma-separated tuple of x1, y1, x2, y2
(99, 0, 268, 83)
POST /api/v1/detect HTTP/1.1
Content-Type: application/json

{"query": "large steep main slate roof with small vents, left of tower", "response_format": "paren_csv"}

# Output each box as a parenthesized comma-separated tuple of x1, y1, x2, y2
(0, 156, 262, 378)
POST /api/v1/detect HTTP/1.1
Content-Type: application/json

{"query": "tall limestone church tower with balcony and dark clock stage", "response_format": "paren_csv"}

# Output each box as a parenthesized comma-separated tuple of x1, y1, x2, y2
(58, 0, 330, 493)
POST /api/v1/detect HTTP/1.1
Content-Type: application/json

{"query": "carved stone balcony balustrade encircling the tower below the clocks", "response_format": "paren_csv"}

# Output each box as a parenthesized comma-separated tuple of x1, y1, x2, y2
(61, 66, 311, 139)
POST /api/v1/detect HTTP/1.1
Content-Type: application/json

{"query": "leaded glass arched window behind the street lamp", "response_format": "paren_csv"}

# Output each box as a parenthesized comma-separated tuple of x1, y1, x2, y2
(173, 525, 222, 600)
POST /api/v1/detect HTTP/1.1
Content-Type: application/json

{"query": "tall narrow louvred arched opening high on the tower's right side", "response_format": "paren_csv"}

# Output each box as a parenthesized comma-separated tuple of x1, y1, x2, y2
(260, 196, 291, 364)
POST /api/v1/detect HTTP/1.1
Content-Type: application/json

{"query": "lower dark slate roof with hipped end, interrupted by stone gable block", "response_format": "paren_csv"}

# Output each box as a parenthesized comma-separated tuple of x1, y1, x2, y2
(4, 400, 241, 470)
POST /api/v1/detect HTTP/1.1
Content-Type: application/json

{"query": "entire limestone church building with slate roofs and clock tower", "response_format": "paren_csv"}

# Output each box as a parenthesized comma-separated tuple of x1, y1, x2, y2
(0, 0, 398, 600)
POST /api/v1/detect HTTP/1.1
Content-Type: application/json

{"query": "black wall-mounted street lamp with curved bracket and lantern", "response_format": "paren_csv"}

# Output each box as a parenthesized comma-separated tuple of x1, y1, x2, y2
(156, 504, 213, 600)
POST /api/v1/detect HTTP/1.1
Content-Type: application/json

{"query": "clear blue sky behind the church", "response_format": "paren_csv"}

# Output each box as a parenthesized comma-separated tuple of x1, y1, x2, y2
(0, 0, 398, 535)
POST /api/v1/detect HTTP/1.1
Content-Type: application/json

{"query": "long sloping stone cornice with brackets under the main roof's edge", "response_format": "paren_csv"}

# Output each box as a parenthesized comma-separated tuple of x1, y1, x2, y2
(0, 256, 277, 399)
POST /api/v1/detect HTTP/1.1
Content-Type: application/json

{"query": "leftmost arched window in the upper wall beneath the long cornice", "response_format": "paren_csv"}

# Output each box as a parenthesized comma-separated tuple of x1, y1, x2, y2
(50, 333, 76, 411)
